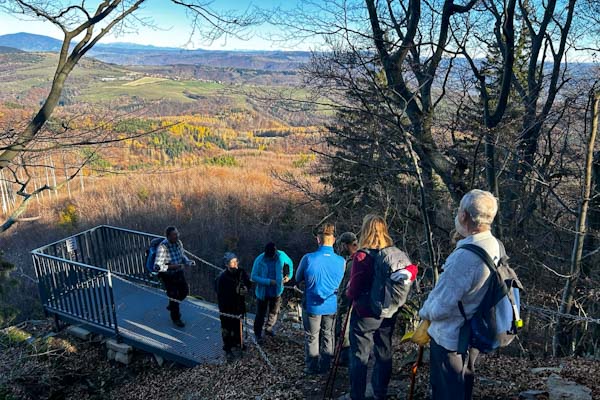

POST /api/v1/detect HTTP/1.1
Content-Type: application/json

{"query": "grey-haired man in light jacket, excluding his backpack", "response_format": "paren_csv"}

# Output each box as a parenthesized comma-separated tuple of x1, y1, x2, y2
(419, 189, 500, 400)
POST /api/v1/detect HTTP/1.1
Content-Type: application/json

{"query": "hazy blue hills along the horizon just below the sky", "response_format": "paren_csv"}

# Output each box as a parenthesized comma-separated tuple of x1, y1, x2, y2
(0, 33, 311, 71)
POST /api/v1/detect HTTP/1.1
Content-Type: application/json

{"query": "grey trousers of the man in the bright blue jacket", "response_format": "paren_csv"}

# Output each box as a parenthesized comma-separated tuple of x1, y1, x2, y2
(302, 310, 335, 372)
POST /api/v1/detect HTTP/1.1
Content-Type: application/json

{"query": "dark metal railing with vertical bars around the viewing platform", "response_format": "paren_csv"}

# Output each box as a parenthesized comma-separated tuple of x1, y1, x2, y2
(31, 225, 220, 336)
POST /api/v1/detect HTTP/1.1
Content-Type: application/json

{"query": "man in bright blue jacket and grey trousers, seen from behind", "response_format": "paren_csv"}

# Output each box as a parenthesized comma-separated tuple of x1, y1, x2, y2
(296, 224, 344, 375)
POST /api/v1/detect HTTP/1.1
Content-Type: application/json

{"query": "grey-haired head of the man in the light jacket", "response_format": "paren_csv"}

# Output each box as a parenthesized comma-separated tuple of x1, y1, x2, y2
(454, 189, 498, 237)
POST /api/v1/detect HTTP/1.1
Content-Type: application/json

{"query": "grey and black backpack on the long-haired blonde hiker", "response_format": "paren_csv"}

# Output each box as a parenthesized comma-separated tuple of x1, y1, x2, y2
(360, 246, 412, 318)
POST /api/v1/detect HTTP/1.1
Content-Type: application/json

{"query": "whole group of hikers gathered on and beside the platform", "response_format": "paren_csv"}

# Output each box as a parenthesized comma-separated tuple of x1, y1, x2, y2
(149, 189, 521, 400)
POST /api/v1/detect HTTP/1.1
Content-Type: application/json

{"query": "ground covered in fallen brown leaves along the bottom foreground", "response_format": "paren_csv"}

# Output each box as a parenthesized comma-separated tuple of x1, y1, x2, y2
(0, 322, 600, 400)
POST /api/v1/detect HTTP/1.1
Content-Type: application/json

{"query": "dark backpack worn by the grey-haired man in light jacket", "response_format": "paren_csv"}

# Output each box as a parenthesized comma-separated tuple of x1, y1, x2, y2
(458, 241, 523, 354)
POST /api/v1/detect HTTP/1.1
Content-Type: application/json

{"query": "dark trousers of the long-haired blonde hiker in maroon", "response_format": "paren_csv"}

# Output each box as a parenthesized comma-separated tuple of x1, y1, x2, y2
(350, 310, 396, 400)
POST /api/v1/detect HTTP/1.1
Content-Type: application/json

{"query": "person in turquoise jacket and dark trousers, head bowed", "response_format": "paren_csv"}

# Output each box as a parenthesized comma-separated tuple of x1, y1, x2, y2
(250, 242, 294, 341)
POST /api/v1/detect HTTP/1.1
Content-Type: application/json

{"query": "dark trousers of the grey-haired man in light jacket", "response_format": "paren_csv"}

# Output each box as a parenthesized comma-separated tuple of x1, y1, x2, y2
(429, 338, 479, 400)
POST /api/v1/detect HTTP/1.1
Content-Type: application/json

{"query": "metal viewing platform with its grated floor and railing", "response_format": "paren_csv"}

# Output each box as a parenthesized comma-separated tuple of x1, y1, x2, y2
(31, 225, 244, 366)
